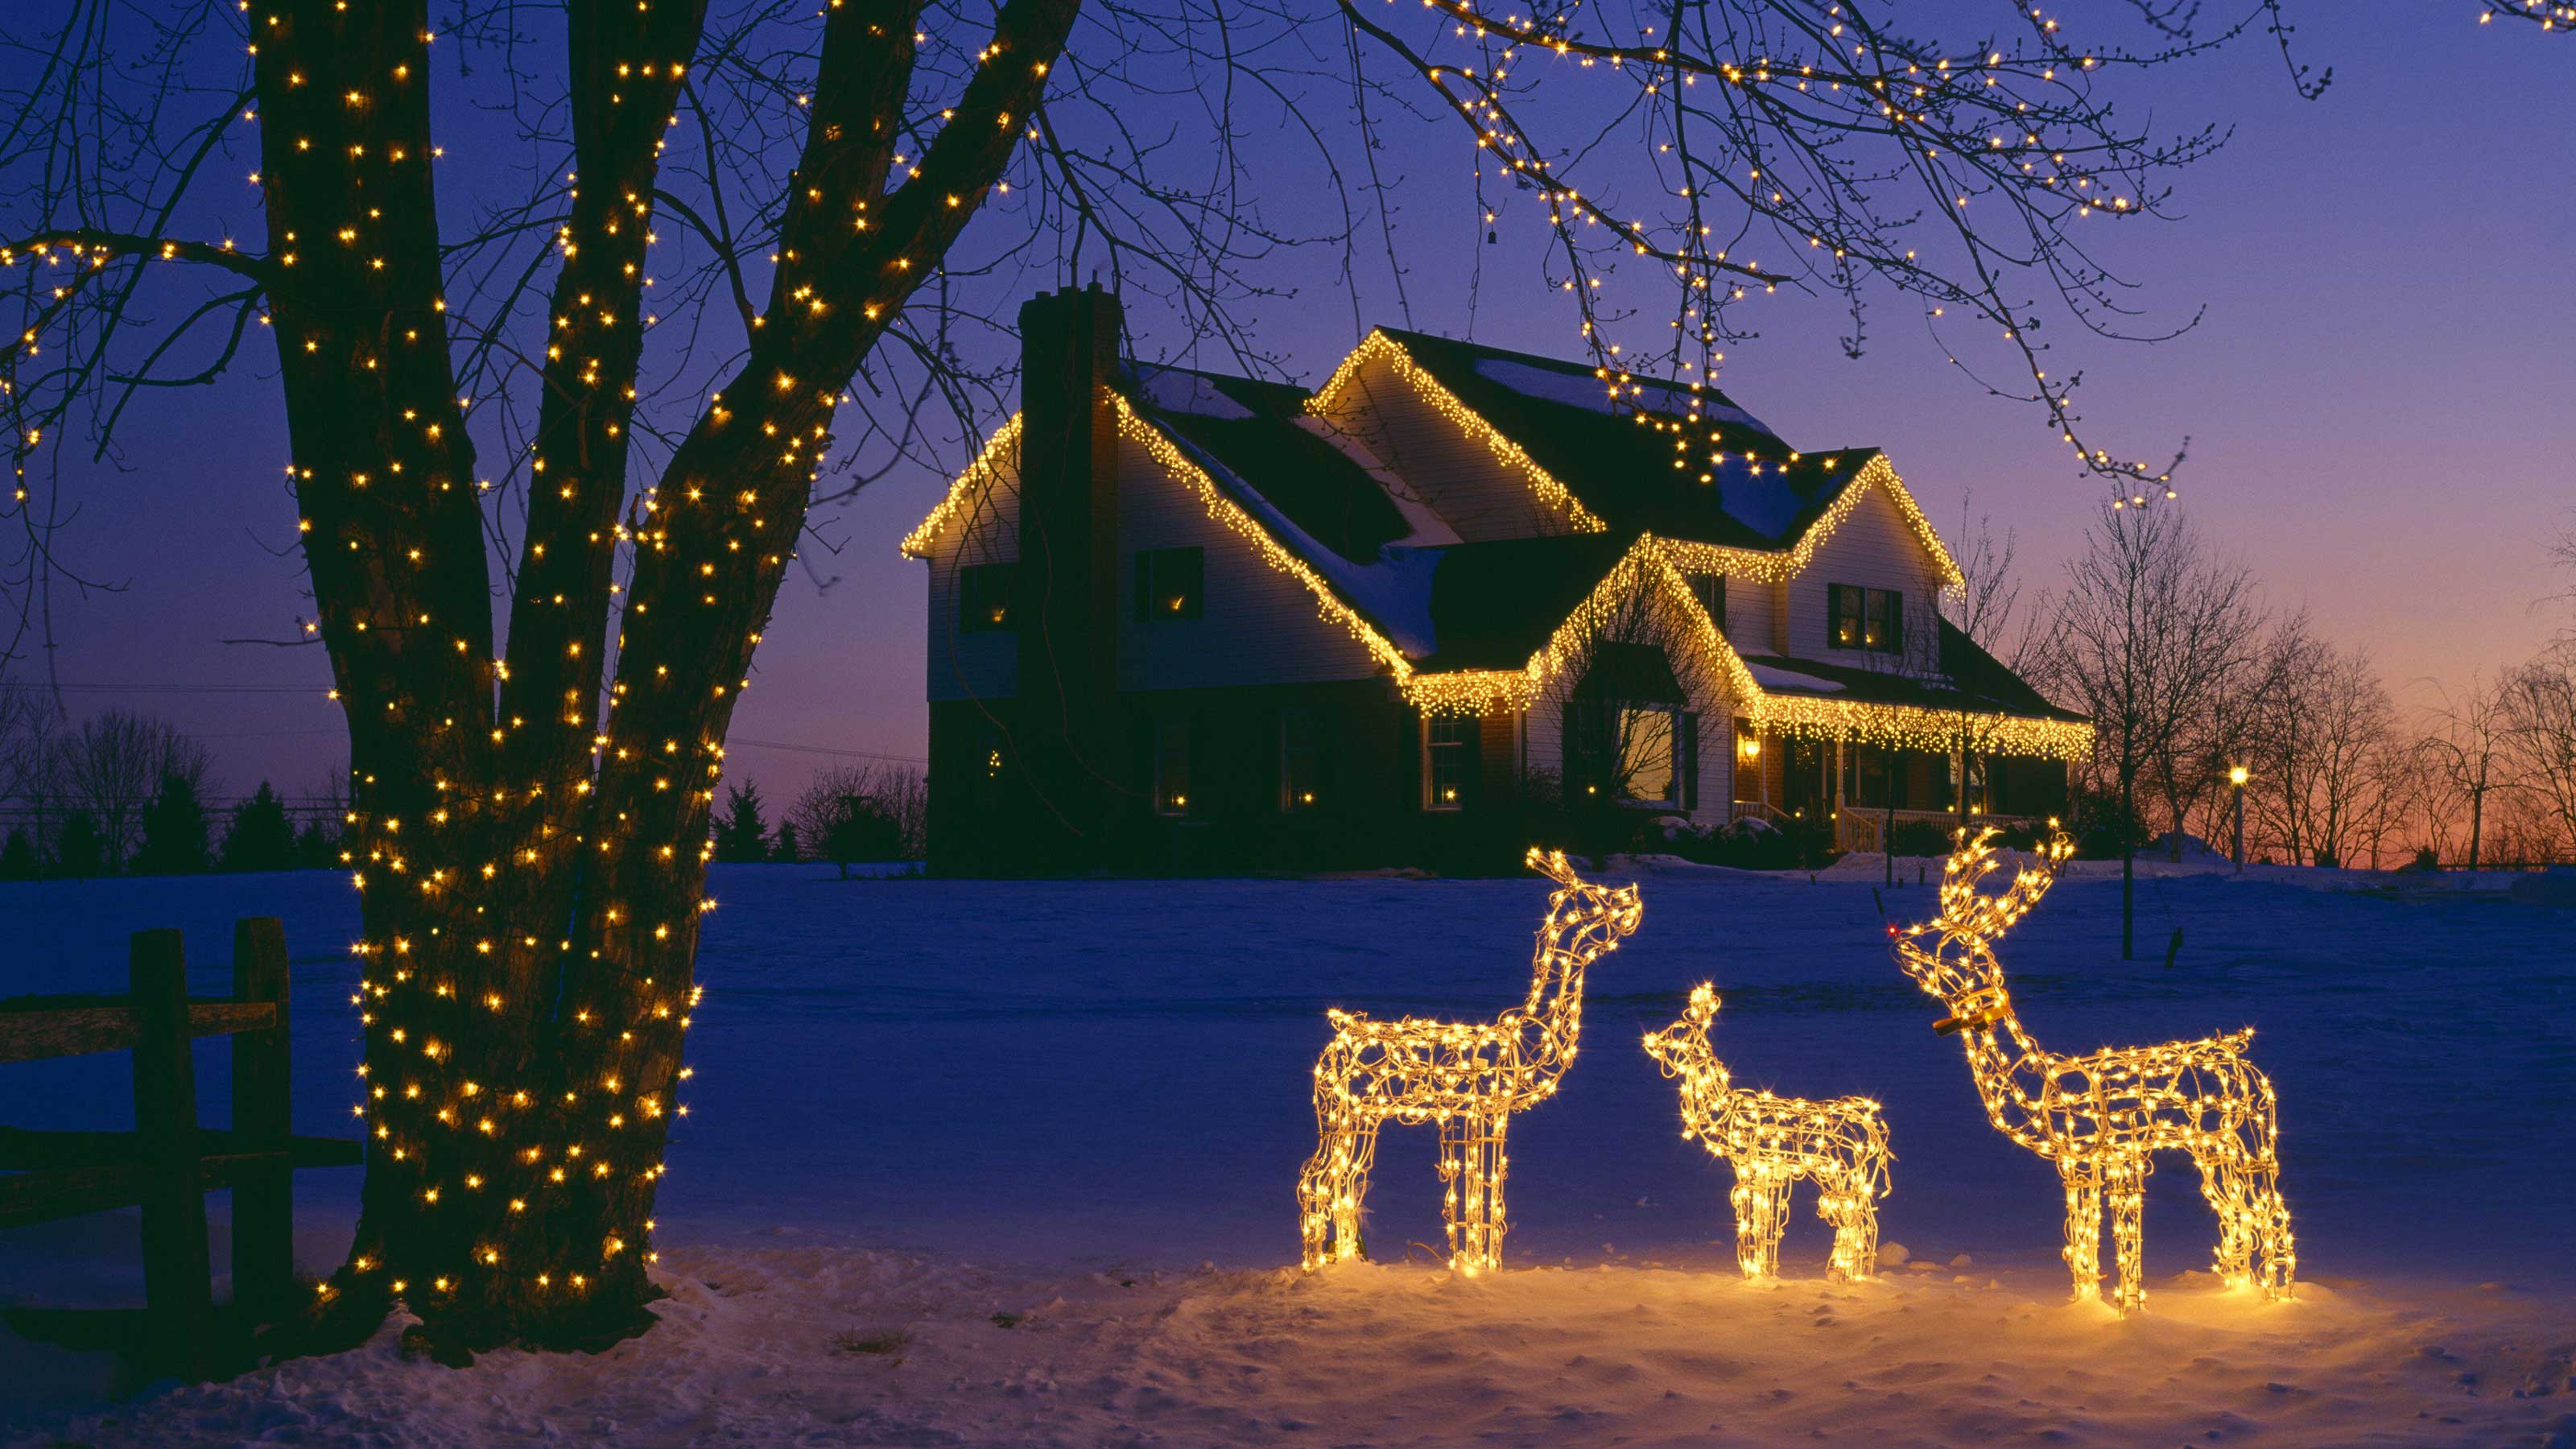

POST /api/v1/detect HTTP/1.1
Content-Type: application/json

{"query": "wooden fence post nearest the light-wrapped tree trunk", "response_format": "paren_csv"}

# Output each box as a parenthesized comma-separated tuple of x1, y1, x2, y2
(232, 915, 296, 1323)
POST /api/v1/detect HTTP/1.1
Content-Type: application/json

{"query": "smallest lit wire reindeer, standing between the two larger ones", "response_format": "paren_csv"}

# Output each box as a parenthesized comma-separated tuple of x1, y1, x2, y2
(1646, 982, 1893, 1282)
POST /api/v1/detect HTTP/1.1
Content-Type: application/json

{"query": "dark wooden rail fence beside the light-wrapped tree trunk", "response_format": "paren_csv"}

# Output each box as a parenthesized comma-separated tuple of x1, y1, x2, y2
(0, 915, 361, 1380)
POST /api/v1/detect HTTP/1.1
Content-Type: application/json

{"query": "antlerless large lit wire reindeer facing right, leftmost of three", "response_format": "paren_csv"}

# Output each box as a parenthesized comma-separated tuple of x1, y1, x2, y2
(1296, 848, 1644, 1274)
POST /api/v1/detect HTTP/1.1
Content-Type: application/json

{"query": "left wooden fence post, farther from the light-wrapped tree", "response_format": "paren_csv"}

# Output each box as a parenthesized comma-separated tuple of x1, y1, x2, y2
(129, 931, 214, 1380)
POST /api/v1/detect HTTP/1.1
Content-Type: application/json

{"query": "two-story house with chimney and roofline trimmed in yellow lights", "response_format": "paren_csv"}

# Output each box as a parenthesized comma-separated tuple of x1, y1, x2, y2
(904, 287, 2089, 872)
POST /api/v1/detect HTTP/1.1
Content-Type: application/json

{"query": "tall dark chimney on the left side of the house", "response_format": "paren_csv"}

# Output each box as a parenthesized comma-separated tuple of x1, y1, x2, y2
(1013, 281, 1136, 866)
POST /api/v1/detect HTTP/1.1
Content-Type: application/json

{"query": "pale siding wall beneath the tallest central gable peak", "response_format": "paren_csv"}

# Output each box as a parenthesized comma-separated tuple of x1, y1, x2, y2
(1329, 356, 1571, 544)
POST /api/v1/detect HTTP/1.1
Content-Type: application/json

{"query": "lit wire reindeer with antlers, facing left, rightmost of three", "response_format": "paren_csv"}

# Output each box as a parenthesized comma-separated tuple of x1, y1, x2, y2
(1889, 828, 2297, 1312)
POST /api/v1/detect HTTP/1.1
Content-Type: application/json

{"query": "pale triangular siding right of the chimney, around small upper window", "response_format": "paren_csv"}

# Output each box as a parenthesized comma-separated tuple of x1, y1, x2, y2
(1113, 427, 1381, 688)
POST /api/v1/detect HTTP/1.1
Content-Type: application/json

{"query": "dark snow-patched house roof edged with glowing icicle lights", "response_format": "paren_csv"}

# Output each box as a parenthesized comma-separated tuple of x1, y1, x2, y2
(904, 330, 2061, 758)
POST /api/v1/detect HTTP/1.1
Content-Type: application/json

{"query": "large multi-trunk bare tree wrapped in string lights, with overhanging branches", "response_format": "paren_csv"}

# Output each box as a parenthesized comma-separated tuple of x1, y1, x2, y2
(0, 0, 2314, 1359)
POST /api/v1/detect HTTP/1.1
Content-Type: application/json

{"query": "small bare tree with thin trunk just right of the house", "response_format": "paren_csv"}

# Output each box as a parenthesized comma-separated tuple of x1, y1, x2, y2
(2043, 506, 2259, 959)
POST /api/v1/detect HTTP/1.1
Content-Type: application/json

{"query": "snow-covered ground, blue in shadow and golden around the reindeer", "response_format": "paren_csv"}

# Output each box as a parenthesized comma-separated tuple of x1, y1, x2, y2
(0, 861, 2576, 1447)
